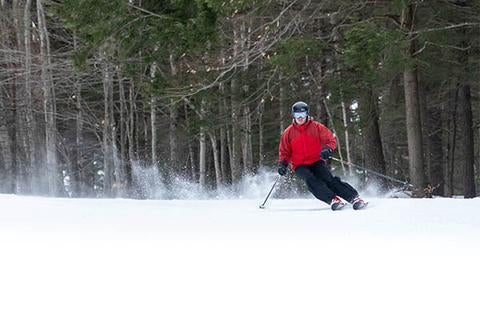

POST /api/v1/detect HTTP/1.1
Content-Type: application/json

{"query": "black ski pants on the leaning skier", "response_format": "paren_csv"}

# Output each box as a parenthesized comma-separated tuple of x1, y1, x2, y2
(295, 160, 358, 204)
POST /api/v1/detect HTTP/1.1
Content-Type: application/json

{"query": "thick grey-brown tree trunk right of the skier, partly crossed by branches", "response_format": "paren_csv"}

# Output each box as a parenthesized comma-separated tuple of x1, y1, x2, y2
(403, 4, 425, 196)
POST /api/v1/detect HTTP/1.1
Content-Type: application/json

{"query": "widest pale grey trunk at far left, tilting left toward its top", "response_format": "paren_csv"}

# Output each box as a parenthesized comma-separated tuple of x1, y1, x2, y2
(37, 0, 59, 196)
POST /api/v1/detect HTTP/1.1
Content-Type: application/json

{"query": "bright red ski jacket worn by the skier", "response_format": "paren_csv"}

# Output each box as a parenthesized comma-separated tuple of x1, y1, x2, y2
(278, 119, 337, 170)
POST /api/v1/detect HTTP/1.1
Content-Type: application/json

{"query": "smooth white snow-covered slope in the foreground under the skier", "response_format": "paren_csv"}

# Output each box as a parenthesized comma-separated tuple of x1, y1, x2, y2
(0, 195, 480, 320)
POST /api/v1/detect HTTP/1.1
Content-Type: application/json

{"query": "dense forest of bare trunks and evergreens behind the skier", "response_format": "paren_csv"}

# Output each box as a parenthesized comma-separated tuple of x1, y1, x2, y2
(0, 0, 480, 197)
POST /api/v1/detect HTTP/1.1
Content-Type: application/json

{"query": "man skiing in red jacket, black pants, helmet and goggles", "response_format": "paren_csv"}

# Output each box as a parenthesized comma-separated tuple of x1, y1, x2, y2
(278, 101, 366, 210)
